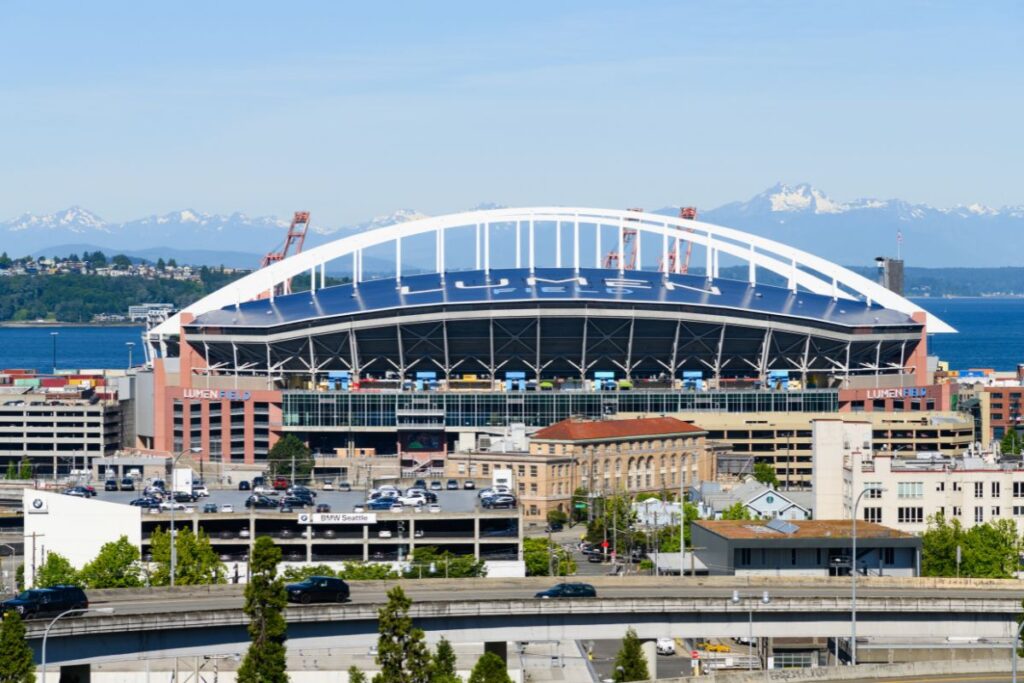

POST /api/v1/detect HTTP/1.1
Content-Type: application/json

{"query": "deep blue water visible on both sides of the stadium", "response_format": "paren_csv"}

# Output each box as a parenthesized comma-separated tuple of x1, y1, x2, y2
(0, 298, 1024, 372)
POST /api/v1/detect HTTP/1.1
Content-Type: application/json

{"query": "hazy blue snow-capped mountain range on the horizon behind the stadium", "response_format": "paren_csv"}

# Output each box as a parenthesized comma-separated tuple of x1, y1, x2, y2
(0, 183, 1024, 267)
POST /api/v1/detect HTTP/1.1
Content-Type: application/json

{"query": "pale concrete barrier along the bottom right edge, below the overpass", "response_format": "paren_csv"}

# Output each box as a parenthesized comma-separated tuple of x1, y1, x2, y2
(648, 656, 1024, 683)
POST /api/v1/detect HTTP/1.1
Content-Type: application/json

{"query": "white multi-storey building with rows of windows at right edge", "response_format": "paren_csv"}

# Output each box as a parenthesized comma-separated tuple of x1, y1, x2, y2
(813, 420, 1024, 533)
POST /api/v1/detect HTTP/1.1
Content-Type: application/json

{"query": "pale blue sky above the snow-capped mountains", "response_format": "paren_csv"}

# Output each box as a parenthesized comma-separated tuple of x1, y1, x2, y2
(0, 0, 1024, 224)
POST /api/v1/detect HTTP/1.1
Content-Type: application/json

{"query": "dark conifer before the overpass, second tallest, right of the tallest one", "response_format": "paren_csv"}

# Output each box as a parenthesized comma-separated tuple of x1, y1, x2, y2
(374, 586, 430, 683)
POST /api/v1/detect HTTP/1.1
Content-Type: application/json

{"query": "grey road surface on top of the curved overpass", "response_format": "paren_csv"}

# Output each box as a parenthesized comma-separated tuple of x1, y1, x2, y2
(66, 577, 1020, 614)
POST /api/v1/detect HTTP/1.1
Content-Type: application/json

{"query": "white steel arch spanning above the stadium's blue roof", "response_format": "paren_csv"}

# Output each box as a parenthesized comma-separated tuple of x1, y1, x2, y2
(150, 207, 955, 341)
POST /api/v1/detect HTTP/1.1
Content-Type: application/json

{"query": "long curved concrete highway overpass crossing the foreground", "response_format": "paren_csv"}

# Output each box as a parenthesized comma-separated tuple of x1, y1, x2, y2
(29, 577, 1024, 665)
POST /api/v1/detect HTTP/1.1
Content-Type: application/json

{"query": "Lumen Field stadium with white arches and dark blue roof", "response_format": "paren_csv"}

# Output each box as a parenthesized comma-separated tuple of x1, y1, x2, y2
(130, 208, 952, 462)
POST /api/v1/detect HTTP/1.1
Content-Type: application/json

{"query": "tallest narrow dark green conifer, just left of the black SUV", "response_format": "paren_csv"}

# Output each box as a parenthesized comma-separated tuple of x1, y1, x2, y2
(238, 536, 288, 683)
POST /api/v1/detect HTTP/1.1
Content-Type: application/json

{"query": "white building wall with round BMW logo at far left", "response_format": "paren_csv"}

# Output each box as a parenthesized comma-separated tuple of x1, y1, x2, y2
(23, 488, 142, 586)
